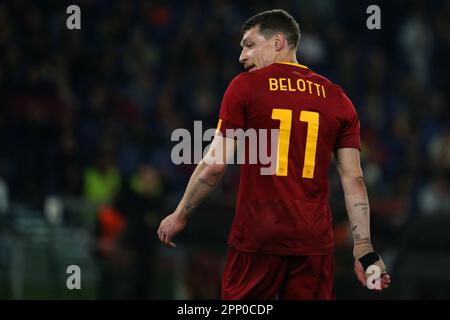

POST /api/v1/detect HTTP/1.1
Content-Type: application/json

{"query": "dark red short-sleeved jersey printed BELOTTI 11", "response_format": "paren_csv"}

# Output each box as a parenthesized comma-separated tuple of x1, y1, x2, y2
(219, 63, 360, 255)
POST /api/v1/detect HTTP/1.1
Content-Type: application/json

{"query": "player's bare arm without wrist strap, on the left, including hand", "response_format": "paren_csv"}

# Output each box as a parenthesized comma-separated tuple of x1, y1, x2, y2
(158, 134, 236, 248)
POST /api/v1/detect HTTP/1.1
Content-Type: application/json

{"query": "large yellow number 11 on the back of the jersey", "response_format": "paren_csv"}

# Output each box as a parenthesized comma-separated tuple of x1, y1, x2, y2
(272, 109, 319, 179)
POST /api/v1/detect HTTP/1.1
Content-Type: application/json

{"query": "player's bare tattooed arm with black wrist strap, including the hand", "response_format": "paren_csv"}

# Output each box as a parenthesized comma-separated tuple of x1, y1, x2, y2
(335, 148, 390, 290)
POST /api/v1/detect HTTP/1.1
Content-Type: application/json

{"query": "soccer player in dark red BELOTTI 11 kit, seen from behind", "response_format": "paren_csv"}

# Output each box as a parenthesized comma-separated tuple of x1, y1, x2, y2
(158, 10, 390, 299)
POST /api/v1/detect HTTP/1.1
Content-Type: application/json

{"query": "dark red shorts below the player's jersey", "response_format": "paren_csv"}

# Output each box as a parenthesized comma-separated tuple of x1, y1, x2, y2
(221, 248, 335, 300)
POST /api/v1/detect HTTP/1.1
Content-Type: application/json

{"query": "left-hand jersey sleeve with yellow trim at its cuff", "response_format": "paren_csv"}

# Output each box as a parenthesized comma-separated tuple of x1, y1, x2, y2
(217, 74, 249, 136)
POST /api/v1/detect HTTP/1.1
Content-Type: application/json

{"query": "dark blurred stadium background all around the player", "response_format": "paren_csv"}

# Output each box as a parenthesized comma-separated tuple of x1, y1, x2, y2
(0, 0, 450, 299)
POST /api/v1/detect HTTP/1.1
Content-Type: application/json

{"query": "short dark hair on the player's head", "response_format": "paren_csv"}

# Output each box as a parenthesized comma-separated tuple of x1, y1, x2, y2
(242, 9, 300, 49)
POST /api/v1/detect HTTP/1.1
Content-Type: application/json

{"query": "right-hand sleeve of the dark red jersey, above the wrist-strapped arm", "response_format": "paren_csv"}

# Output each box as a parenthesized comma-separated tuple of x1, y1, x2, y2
(334, 91, 361, 150)
